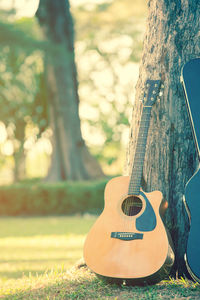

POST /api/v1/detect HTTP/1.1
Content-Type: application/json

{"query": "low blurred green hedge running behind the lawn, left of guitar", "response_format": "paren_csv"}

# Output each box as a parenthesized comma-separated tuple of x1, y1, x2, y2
(0, 179, 107, 216)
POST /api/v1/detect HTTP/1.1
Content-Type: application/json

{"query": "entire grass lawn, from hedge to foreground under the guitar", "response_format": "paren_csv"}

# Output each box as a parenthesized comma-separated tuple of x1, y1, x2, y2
(0, 216, 200, 300)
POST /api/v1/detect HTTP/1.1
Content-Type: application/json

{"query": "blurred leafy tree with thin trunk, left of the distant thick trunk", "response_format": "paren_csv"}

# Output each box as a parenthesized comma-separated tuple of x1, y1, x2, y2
(0, 12, 46, 180)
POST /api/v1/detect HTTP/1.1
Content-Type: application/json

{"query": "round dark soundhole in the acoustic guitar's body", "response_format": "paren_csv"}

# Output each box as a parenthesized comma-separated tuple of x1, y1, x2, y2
(122, 196, 142, 216)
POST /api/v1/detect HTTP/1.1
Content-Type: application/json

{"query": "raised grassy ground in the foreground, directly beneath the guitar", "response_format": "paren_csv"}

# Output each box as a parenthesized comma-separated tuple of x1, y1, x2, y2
(2, 268, 200, 300)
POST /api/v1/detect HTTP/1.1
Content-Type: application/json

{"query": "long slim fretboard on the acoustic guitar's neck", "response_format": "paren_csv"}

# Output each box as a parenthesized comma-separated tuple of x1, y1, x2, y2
(128, 106, 152, 195)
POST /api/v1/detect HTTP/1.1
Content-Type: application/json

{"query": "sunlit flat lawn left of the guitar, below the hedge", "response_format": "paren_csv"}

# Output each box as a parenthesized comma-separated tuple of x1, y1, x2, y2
(0, 217, 95, 295)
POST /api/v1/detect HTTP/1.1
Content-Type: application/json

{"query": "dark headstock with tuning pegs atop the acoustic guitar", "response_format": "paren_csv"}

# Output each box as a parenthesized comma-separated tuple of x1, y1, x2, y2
(143, 79, 161, 106)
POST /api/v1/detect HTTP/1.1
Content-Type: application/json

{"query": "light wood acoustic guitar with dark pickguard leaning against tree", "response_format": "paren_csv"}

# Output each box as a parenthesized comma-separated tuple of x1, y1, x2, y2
(84, 80, 174, 285)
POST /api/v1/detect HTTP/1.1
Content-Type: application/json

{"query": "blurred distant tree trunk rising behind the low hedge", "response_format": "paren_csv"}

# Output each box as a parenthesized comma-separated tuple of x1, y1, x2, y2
(36, 0, 103, 181)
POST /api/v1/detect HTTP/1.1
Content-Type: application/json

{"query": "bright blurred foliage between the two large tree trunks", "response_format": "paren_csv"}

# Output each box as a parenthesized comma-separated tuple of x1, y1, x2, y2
(72, 0, 147, 174)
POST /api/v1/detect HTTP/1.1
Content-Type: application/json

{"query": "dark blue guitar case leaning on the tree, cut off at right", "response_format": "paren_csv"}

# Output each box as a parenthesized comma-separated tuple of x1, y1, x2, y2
(181, 58, 200, 282)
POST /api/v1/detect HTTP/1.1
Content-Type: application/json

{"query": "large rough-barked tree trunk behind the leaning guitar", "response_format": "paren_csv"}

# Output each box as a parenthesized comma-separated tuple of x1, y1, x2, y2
(128, 0, 200, 276)
